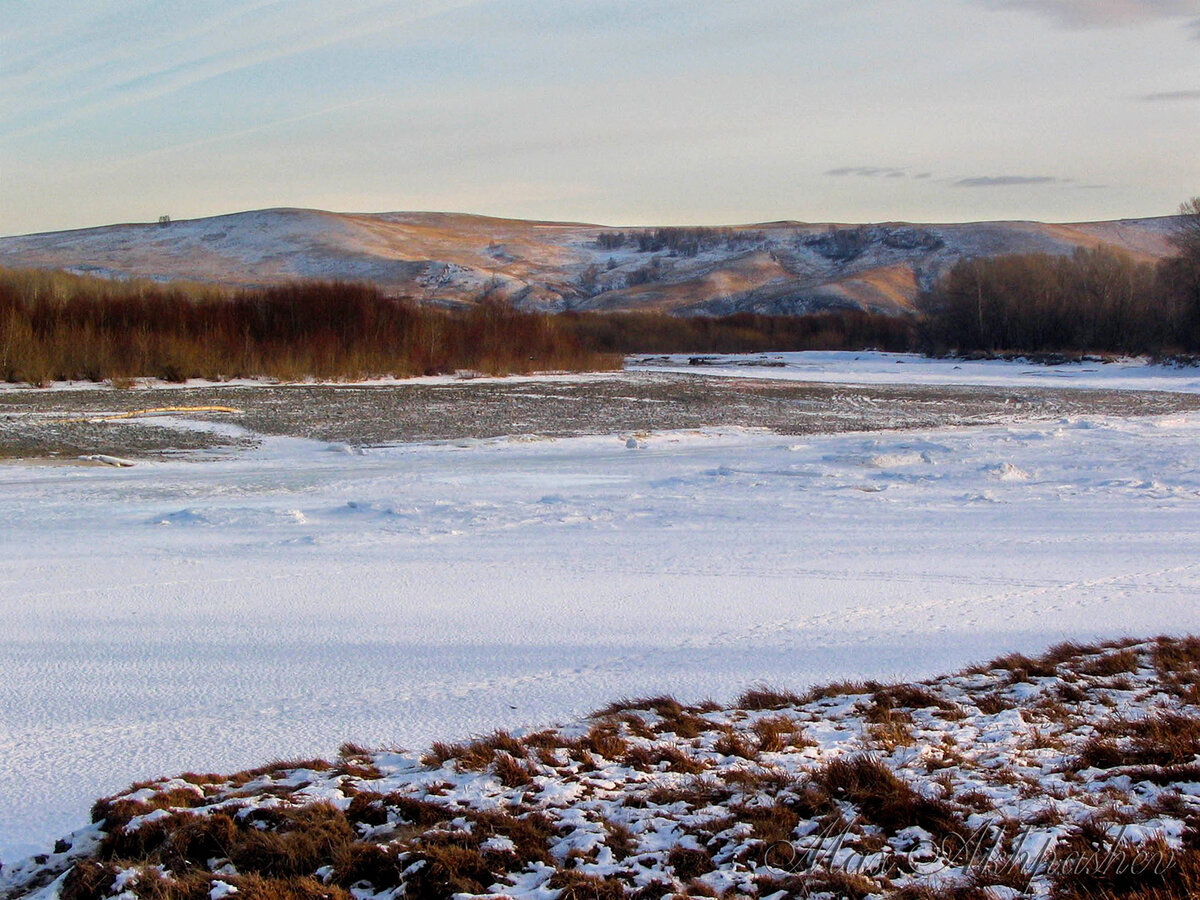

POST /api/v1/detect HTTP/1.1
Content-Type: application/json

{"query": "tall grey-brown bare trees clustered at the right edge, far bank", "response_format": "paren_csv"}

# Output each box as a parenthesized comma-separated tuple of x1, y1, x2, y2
(918, 250, 1200, 356)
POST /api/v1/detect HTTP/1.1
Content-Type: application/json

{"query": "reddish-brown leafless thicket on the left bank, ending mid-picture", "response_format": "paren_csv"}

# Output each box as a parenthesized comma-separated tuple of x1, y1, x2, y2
(0, 270, 620, 384)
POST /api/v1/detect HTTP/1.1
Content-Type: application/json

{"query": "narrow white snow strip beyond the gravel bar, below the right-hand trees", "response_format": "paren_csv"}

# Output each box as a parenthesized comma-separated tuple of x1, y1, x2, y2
(625, 350, 1200, 394)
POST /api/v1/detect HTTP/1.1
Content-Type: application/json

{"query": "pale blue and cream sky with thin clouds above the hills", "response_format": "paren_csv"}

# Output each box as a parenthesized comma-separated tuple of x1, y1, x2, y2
(0, 0, 1200, 234)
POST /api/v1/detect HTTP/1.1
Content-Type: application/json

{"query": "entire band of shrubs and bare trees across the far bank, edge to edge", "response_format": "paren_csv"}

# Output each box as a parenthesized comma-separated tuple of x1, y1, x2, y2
(9, 198, 1200, 384)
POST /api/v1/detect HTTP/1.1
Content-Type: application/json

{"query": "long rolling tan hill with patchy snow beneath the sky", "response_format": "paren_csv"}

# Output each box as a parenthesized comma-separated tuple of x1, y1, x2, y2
(0, 209, 1175, 314)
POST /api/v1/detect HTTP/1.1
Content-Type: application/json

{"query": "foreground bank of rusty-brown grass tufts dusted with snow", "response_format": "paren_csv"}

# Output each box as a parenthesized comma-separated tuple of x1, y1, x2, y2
(9, 638, 1200, 900)
